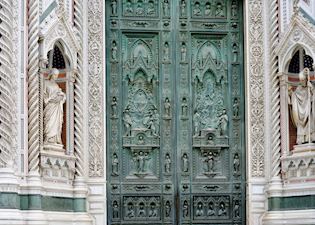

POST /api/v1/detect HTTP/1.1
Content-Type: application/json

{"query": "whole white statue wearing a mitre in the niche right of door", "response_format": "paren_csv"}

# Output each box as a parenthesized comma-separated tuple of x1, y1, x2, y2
(289, 68, 315, 145)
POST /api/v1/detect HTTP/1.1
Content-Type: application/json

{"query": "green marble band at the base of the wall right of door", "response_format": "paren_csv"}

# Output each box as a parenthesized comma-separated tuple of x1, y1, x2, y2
(268, 195, 315, 211)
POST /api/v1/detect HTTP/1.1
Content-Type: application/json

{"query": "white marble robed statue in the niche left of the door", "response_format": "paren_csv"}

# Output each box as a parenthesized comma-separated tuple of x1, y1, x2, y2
(44, 69, 66, 145)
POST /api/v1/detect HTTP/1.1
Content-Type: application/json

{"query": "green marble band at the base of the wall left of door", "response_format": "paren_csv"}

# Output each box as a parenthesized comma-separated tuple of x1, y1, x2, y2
(0, 193, 86, 212)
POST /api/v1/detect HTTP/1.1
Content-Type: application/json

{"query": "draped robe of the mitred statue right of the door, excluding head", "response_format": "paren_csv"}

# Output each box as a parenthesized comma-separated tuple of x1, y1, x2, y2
(291, 85, 315, 144)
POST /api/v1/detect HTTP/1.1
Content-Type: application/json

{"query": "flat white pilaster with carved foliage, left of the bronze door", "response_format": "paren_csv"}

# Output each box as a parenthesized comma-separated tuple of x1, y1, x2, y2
(88, 0, 104, 177)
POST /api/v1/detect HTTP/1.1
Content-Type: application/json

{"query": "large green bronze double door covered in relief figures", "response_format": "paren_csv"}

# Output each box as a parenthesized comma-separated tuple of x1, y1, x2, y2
(106, 0, 245, 225)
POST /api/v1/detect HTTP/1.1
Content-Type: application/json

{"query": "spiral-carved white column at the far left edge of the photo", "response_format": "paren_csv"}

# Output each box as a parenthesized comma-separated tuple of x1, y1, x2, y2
(0, 0, 16, 168)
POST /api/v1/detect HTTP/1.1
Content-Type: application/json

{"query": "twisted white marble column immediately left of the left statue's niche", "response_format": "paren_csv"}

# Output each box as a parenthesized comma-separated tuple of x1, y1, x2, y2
(28, 0, 40, 172)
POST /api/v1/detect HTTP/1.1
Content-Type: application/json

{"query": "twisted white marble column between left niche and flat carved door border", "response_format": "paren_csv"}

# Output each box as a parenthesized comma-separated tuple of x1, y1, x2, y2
(74, 0, 84, 177)
